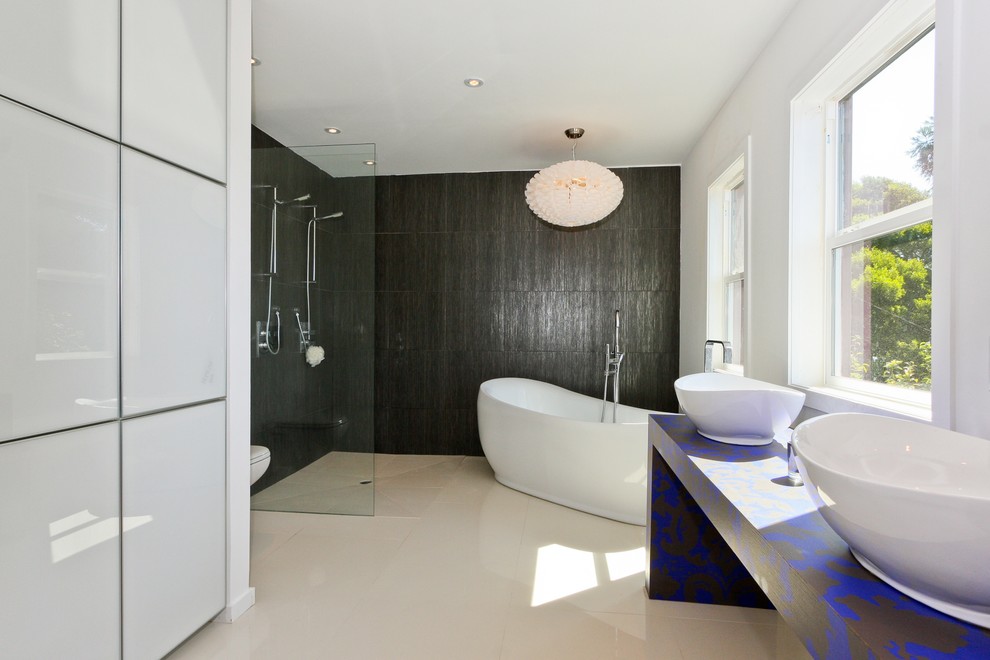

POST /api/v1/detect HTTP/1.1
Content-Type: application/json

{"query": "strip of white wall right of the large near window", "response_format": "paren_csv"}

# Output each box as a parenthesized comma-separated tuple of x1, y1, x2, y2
(932, 0, 990, 438)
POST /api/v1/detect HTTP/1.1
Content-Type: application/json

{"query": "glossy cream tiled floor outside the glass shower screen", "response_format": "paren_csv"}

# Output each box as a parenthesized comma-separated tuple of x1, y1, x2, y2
(170, 455, 808, 660)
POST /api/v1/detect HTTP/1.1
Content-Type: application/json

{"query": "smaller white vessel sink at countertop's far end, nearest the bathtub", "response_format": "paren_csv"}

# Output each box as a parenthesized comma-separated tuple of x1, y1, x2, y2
(674, 372, 804, 446)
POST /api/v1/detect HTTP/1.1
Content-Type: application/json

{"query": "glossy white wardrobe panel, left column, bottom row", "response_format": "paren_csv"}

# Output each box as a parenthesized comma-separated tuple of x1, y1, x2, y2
(0, 422, 121, 660)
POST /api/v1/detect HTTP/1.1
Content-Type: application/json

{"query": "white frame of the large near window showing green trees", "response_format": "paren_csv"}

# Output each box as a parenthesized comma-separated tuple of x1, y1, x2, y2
(789, 0, 935, 420)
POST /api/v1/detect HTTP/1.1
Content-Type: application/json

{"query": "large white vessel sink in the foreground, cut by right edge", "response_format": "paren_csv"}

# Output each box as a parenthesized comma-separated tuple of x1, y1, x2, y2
(792, 413, 990, 627)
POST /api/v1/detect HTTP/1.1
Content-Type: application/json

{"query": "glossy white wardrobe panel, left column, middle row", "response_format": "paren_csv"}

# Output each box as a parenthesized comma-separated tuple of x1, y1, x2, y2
(0, 100, 120, 440)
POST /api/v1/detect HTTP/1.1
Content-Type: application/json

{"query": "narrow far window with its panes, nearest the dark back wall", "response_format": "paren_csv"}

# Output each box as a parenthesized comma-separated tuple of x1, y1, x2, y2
(708, 155, 748, 374)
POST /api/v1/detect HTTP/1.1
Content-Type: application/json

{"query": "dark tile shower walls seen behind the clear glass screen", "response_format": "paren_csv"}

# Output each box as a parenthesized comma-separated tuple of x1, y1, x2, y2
(250, 129, 376, 492)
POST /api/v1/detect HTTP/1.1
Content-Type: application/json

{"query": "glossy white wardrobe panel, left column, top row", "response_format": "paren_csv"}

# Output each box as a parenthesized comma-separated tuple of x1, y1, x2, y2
(0, 0, 120, 139)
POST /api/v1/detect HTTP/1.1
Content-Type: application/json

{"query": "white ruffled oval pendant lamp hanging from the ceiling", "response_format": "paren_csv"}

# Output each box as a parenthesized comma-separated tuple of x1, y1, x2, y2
(526, 128, 622, 227)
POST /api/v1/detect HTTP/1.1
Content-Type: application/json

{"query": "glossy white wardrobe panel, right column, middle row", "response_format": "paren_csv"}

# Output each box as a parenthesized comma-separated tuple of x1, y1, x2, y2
(121, 148, 226, 416)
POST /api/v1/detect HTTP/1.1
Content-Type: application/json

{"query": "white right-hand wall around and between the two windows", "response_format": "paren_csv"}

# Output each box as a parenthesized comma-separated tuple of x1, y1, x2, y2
(680, 0, 990, 437)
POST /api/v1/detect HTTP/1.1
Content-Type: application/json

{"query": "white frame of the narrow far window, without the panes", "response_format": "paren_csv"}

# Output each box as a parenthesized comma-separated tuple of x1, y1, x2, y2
(706, 138, 752, 376)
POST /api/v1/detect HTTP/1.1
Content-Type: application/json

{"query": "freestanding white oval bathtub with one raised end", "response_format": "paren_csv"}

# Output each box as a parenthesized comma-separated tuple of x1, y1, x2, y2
(478, 378, 655, 525)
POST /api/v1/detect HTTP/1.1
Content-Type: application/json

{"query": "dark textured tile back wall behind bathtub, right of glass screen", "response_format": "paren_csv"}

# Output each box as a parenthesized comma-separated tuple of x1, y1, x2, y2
(374, 167, 680, 455)
